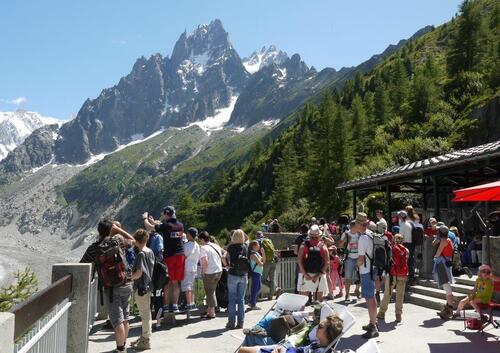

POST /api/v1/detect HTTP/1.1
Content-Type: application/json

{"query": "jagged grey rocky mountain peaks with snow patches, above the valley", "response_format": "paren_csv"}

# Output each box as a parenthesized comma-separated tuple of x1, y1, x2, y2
(54, 20, 434, 164)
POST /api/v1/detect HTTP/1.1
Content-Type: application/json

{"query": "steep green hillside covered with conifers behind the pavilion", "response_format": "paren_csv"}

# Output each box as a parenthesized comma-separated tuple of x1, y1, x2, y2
(200, 0, 500, 235)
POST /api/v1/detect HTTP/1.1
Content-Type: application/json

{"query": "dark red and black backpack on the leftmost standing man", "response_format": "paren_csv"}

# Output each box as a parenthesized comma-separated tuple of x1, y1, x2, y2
(95, 236, 130, 288)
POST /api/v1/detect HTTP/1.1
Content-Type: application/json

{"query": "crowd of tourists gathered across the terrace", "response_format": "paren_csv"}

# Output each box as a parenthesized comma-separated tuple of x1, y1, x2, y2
(81, 206, 498, 353)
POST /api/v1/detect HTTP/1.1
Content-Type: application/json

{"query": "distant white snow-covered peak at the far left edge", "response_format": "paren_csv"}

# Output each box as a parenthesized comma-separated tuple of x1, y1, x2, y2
(0, 109, 60, 160)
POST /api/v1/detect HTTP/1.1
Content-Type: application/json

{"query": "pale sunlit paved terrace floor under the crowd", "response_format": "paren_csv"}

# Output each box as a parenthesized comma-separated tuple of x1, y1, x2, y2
(89, 299, 500, 353)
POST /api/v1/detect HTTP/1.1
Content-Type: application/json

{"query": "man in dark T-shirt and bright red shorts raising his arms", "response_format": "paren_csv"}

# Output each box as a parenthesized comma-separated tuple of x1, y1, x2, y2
(142, 206, 186, 313)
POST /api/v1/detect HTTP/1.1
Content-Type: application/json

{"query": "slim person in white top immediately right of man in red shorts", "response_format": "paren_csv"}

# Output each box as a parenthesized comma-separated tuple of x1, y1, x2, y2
(181, 227, 200, 311)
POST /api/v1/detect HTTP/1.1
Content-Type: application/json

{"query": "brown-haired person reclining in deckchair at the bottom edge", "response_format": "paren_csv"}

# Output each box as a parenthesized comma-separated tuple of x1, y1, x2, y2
(238, 315, 344, 353)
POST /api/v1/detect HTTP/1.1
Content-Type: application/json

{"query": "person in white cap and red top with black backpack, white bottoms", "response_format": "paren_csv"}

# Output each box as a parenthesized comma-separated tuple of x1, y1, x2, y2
(297, 224, 329, 301)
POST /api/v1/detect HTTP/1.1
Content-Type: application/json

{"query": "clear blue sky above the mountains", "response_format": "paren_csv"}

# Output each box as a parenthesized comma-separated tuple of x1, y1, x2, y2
(0, 0, 461, 119)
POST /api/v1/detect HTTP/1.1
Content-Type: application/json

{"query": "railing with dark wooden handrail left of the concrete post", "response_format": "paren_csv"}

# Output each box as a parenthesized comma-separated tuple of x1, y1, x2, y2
(11, 275, 72, 353)
